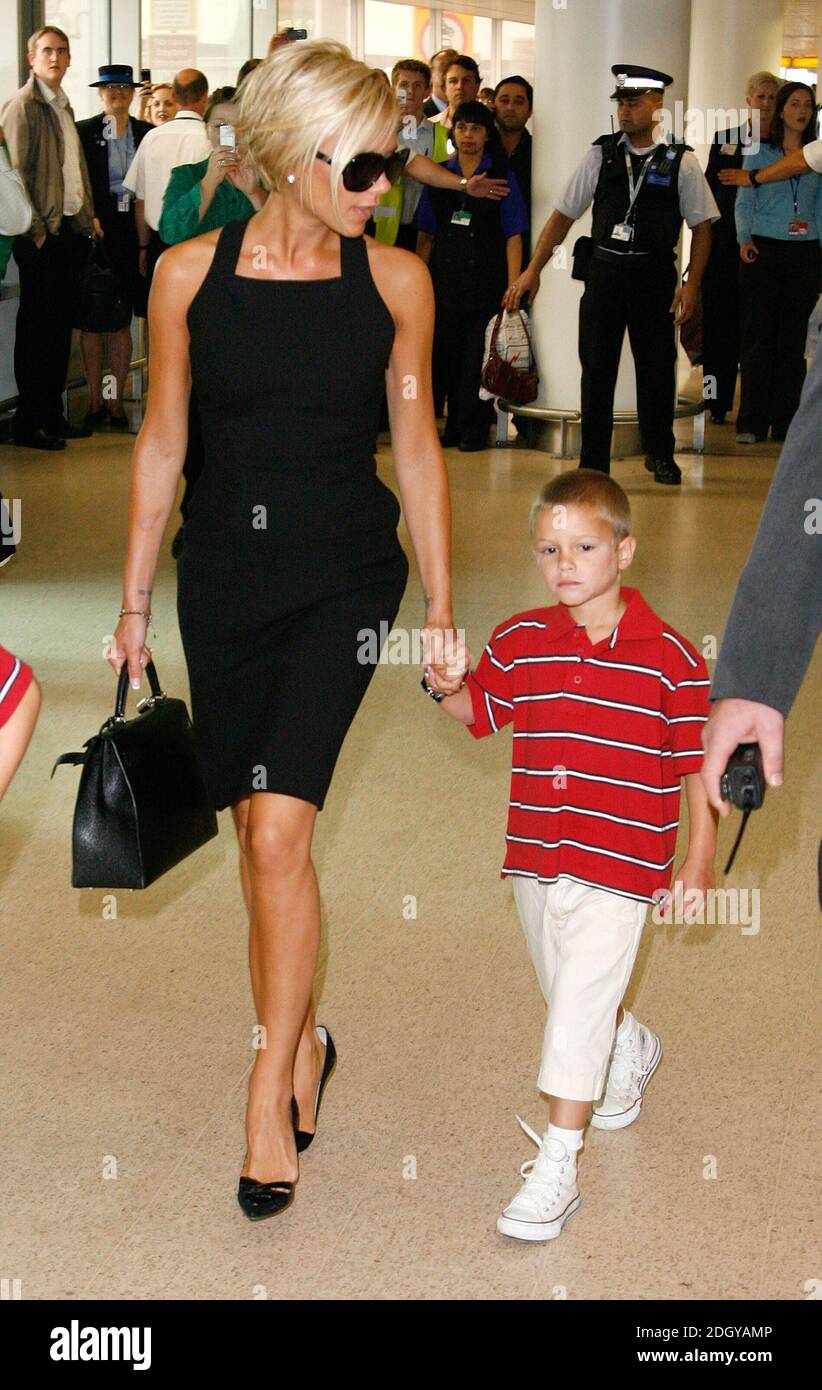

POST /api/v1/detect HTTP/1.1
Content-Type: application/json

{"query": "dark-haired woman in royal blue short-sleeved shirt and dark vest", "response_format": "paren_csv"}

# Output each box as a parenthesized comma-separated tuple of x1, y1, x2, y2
(416, 101, 529, 452)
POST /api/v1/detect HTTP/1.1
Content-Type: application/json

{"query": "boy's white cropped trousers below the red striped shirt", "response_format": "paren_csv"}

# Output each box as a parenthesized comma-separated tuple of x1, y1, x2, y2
(512, 874, 648, 1101)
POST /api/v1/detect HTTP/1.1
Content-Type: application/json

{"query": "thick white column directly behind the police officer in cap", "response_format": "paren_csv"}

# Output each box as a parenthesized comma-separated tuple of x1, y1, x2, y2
(531, 0, 692, 410)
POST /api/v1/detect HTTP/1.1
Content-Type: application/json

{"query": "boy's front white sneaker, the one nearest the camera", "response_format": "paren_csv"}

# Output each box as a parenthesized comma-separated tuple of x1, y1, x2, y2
(497, 1115, 580, 1240)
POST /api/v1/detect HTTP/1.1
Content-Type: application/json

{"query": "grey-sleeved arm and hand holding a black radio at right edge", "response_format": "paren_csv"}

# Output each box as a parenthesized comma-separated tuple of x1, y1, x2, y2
(702, 341, 822, 887)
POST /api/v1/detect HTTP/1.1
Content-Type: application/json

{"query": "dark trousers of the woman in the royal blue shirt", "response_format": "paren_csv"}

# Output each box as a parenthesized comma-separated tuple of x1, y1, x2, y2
(433, 296, 495, 441)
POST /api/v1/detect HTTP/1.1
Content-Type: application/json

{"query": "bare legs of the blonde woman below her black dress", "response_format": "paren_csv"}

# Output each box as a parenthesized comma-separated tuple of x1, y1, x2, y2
(232, 792, 323, 1183)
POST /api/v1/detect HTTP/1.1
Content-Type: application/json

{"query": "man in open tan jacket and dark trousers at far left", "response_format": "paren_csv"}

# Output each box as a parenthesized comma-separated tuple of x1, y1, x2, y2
(0, 28, 102, 449)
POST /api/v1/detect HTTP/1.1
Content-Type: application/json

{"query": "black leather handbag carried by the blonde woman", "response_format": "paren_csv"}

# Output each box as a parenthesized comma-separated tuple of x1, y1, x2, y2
(51, 662, 217, 888)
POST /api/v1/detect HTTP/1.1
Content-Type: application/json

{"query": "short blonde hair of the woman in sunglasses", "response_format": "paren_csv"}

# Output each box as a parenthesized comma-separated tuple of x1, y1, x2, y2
(236, 40, 402, 215)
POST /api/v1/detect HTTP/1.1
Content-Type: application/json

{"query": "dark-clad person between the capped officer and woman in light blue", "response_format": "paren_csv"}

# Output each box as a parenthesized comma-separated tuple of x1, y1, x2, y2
(702, 72, 782, 424)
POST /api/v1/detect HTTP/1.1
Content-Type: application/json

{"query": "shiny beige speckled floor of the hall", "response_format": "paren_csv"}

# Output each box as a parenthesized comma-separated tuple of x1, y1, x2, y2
(0, 405, 822, 1300)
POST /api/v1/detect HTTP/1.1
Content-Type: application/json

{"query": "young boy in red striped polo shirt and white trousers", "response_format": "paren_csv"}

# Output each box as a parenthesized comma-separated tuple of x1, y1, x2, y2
(426, 468, 716, 1240)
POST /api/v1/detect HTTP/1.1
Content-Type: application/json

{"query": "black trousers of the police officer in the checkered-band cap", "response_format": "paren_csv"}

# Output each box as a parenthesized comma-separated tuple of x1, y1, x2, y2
(580, 259, 676, 473)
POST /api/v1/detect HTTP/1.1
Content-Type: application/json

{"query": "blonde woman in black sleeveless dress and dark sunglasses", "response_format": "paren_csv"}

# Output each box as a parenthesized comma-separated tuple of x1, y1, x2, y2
(111, 43, 470, 1219)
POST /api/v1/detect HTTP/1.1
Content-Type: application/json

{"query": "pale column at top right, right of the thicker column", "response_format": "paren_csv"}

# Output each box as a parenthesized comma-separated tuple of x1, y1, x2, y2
(686, 0, 784, 168)
